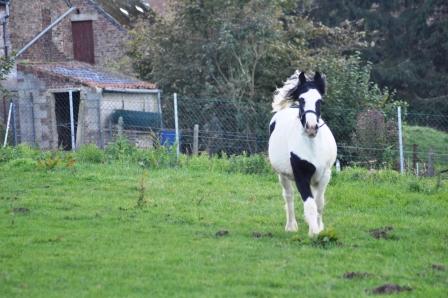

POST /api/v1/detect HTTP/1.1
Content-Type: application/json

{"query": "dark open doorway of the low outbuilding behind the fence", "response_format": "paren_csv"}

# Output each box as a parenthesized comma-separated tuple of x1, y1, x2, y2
(54, 92, 80, 150)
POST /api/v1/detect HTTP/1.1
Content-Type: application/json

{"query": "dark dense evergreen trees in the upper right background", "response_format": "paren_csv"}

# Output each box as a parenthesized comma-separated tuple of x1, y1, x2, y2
(307, 0, 448, 114)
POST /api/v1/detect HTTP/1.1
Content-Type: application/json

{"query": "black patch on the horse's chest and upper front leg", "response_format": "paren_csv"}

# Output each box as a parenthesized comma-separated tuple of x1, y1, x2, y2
(290, 152, 316, 202)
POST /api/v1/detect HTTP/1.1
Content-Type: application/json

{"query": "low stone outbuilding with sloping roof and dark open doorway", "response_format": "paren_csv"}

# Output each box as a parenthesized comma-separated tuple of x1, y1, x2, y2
(16, 61, 161, 150)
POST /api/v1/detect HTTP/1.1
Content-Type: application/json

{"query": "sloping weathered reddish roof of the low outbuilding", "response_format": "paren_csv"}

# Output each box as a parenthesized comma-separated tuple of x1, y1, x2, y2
(17, 61, 157, 89)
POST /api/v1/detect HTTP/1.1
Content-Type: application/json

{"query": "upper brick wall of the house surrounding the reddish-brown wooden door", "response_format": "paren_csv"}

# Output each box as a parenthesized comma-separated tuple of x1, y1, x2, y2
(10, 0, 128, 66)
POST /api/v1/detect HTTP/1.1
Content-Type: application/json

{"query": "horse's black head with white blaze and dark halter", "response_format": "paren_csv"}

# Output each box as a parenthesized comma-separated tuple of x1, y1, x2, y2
(290, 72, 325, 138)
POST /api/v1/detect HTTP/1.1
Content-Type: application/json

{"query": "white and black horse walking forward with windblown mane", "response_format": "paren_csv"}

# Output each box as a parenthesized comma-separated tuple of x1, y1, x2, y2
(269, 71, 337, 236)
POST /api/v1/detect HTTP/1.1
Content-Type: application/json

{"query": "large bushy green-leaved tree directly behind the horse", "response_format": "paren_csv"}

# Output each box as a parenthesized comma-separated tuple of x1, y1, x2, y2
(129, 0, 400, 156)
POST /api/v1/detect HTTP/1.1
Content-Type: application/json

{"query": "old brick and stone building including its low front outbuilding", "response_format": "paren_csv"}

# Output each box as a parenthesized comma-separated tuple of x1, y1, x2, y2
(0, 0, 161, 149)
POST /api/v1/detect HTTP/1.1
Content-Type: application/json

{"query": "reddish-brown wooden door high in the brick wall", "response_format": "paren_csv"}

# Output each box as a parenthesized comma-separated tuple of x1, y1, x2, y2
(72, 21, 95, 64)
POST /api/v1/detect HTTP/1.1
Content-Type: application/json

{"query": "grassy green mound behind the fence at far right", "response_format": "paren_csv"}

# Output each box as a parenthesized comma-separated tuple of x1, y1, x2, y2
(404, 126, 448, 167)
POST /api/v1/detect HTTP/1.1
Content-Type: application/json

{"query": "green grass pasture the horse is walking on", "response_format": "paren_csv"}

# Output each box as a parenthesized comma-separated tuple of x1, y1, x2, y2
(0, 157, 448, 297)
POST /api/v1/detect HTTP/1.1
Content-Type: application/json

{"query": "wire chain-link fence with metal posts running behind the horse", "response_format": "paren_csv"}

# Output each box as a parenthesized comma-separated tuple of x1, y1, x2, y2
(0, 92, 448, 175)
